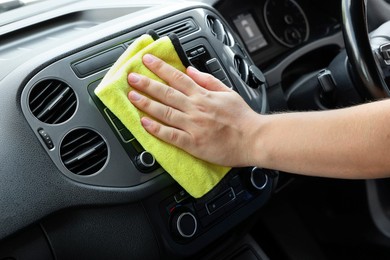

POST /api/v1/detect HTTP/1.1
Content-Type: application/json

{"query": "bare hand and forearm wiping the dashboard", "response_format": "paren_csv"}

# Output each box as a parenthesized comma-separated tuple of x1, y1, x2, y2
(128, 54, 390, 179)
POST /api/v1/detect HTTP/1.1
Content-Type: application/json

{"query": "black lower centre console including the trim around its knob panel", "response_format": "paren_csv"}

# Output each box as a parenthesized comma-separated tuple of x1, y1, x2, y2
(144, 167, 278, 257)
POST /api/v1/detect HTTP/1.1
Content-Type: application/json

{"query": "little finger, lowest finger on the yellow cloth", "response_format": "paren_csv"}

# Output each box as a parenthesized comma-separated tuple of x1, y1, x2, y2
(141, 117, 190, 149)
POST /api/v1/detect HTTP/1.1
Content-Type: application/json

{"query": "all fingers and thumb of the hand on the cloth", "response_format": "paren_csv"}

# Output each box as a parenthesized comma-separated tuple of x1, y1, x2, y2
(128, 54, 232, 150)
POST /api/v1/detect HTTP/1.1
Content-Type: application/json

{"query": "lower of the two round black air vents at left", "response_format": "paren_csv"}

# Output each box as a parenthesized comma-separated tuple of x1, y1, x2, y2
(60, 129, 108, 175)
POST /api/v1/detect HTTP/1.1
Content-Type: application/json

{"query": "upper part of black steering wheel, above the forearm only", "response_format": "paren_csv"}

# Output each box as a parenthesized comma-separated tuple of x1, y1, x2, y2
(342, 0, 390, 99)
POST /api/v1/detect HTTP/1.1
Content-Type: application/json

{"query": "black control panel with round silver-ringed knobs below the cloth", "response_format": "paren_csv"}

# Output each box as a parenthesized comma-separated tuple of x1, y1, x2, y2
(155, 167, 278, 243)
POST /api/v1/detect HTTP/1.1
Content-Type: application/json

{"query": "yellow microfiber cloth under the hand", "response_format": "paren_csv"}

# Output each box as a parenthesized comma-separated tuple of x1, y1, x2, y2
(95, 34, 230, 198)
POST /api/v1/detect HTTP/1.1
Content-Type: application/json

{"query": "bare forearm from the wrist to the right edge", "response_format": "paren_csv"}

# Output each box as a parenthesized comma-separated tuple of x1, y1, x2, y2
(251, 101, 390, 178)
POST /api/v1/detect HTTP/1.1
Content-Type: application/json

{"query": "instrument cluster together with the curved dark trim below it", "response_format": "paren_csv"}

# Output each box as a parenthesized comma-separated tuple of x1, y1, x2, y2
(216, 0, 344, 111)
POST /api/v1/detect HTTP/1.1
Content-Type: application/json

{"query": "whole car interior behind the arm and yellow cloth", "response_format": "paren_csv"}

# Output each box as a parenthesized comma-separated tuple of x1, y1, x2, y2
(0, 0, 390, 260)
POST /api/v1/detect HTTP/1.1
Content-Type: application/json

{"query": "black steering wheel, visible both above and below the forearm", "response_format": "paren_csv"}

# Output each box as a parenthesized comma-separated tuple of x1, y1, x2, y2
(342, 0, 390, 237)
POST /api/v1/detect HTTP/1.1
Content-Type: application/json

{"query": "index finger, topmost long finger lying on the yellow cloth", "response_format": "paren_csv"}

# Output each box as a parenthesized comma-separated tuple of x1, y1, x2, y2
(143, 54, 199, 96)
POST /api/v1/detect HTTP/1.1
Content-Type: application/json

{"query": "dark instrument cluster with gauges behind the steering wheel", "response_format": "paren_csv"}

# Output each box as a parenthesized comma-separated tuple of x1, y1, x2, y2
(217, 0, 340, 69)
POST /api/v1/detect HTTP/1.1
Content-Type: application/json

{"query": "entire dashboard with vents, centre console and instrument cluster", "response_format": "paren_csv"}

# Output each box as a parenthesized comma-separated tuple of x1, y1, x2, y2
(0, 0, 343, 259)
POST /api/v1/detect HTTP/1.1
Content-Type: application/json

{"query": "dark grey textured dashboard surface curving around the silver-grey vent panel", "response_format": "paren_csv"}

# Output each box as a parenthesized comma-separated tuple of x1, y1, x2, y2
(0, 0, 198, 241)
